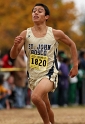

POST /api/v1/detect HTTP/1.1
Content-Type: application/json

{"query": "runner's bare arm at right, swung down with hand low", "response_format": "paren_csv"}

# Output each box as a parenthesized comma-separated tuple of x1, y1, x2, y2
(53, 30, 78, 77)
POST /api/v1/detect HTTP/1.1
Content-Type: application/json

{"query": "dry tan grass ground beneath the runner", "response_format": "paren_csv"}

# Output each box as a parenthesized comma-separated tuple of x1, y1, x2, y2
(0, 107, 85, 124)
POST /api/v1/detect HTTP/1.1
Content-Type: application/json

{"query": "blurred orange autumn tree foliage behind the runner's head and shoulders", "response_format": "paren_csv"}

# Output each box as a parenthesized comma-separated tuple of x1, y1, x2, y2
(0, 0, 82, 53)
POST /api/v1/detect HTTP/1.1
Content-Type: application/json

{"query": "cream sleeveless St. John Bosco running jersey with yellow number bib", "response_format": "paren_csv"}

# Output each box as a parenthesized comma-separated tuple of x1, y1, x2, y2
(24, 27, 58, 80)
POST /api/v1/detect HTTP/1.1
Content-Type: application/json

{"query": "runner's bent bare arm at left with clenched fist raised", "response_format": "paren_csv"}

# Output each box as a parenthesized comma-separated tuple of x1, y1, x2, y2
(10, 30, 26, 59)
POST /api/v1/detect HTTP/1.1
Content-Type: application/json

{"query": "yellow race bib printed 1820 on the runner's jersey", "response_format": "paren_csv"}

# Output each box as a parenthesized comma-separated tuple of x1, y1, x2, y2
(30, 54, 48, 70)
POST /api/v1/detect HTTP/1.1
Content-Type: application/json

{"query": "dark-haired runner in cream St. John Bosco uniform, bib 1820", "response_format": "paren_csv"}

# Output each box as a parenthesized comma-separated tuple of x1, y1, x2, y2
(10, 3, 78, 124)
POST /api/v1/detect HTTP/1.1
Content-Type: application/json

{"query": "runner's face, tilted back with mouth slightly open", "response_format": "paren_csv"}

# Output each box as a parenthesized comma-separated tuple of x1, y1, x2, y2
(32, 6, 47, 22)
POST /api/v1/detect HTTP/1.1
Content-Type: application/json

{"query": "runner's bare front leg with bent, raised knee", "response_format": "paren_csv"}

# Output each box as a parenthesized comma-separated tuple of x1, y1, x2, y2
(31, 79, 54, 124)
